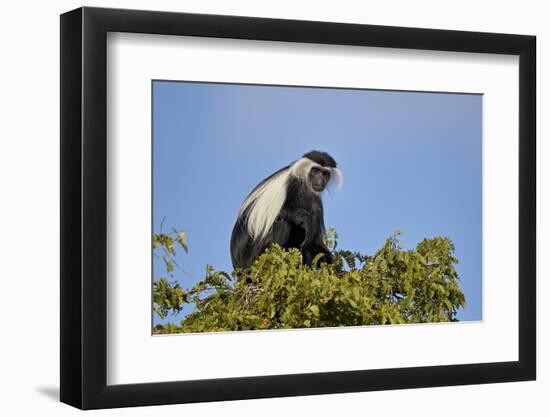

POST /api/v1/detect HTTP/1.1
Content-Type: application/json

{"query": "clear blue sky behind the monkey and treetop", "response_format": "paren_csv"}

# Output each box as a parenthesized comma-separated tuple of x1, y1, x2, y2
(153, 81, 482, 324)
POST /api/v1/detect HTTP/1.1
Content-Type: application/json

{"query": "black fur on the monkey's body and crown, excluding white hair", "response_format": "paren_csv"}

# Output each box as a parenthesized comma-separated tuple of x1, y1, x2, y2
(231, 151, 336, 268)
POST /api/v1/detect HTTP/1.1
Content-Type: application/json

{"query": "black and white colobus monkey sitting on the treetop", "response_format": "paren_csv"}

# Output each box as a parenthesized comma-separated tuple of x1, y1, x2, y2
(231, 151, 342, 268)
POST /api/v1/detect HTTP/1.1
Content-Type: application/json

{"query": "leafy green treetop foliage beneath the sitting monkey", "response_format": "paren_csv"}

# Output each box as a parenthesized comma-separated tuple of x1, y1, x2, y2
(154, 228, 465, 333)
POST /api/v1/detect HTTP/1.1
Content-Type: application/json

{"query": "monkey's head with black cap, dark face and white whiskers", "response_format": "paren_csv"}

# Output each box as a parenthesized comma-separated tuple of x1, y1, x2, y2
(291, 151, 342, 193)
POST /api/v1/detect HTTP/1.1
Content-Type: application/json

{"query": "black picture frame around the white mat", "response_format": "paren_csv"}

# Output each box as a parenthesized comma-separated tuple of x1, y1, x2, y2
(60, 7, 536, 409)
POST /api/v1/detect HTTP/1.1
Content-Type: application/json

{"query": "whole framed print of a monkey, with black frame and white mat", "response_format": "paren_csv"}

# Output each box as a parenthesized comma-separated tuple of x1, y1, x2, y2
(61, 7, 536, 409)
